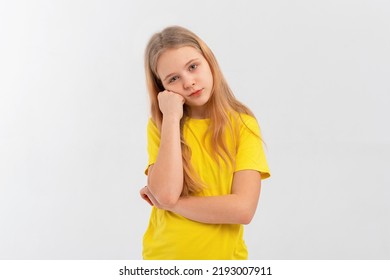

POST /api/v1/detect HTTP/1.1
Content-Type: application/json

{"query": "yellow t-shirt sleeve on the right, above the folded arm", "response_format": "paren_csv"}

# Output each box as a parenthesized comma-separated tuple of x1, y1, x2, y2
(235, 116, 271, 179)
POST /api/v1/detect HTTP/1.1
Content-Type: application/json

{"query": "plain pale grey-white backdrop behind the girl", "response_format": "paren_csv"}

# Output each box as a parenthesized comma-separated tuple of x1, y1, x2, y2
(0, 0, 390, 259)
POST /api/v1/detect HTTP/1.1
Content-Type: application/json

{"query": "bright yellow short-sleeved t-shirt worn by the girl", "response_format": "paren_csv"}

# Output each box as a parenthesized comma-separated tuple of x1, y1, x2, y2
(143, 114, 270, 260)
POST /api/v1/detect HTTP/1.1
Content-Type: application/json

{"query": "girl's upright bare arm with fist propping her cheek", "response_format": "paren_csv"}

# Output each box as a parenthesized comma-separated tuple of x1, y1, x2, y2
(148, 91, 183, 207)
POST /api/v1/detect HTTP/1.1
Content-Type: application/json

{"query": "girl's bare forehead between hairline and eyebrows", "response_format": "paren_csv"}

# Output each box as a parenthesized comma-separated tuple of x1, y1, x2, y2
(157, 47, 203, 78)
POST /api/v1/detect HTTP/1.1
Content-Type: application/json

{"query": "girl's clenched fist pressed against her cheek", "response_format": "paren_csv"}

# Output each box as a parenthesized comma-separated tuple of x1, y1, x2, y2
(157, 90, 185, 120)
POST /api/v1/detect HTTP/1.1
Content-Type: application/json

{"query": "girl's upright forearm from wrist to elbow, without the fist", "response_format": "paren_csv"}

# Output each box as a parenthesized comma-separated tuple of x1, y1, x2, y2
(148, 117, 183, 205)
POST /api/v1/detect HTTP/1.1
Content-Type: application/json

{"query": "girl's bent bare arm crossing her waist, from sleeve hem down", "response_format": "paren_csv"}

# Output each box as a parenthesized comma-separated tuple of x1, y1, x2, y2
(167, 170, 261, 224)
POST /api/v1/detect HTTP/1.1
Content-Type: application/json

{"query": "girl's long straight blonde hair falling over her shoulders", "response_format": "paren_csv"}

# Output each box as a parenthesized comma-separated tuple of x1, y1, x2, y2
(145, 26, 254, 196)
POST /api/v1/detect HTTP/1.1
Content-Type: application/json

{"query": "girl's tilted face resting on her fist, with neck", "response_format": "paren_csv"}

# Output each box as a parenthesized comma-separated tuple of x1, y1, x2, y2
(157, 47, 213, 118)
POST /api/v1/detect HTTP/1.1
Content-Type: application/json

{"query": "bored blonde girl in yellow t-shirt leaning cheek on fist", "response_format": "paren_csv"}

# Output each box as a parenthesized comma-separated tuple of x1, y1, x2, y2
(140, 26, 270, 260)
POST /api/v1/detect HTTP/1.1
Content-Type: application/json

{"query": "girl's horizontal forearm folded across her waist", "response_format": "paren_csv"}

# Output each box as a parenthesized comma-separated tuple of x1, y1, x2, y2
(168, 194, 256, 224)
